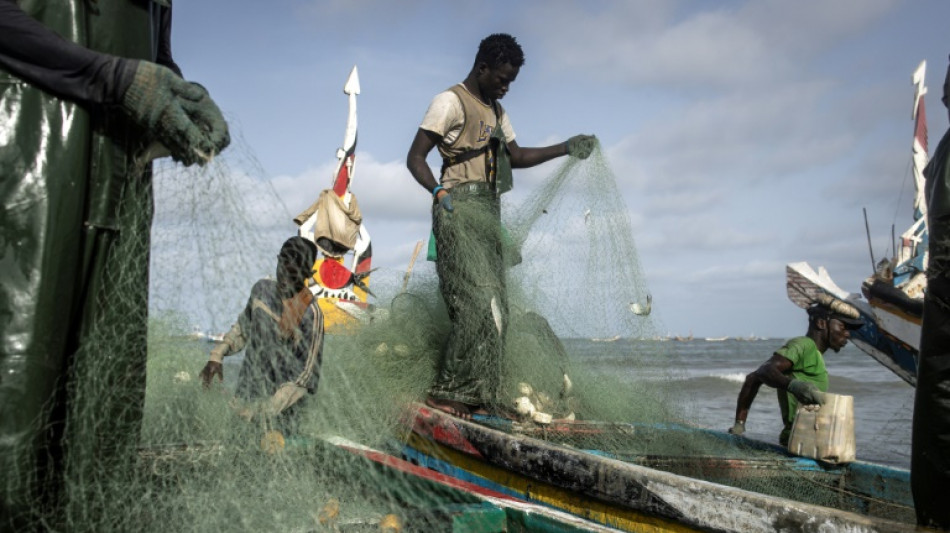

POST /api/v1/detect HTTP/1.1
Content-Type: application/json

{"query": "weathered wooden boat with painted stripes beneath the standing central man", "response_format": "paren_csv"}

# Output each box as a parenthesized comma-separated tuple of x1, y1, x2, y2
(402, 404, 916, 532)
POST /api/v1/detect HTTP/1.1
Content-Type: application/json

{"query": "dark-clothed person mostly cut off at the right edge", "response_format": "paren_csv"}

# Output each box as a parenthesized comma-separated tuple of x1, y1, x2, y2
(910, 53, 950, 529)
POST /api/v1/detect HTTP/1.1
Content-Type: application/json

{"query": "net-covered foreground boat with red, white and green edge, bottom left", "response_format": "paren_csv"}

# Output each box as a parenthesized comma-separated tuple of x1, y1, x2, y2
(139, 437, 617, 533)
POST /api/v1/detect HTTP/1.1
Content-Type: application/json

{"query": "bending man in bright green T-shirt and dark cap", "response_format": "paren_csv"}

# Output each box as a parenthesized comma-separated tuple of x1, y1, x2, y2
(729, 299, 863, 446)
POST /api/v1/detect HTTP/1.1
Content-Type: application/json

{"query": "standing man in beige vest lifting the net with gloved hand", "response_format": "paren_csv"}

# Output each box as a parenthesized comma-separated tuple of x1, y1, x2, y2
(406, 33, 596, 418)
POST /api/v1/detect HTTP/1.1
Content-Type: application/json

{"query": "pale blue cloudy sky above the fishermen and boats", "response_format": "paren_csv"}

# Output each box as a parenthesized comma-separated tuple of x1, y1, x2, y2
(172, 0, 950, 337)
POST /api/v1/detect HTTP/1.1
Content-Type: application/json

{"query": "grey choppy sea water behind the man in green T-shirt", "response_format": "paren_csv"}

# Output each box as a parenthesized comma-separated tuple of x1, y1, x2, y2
(565, 339, 914, 468)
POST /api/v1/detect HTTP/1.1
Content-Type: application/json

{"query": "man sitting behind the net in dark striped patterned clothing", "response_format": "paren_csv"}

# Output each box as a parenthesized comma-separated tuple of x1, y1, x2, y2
(200, 237, 323, 434)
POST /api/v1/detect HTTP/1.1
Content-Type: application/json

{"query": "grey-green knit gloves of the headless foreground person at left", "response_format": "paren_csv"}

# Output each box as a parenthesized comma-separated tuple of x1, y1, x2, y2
(121, 61, 231, 166)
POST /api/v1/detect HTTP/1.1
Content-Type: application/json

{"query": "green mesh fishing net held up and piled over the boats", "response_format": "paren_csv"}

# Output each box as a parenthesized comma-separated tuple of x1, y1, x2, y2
(20, 135, 916, 531)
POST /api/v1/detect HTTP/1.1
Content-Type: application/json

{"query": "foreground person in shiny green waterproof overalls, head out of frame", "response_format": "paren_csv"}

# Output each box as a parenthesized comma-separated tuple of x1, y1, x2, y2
(0, 0, 230, 531)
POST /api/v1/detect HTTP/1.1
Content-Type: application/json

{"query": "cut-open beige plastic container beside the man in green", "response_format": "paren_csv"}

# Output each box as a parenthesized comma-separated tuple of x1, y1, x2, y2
(788, 393, 856, 464)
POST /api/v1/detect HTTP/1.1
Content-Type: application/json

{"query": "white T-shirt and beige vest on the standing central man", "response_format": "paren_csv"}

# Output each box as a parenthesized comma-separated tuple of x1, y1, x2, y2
(419, 83, 515, 189)
